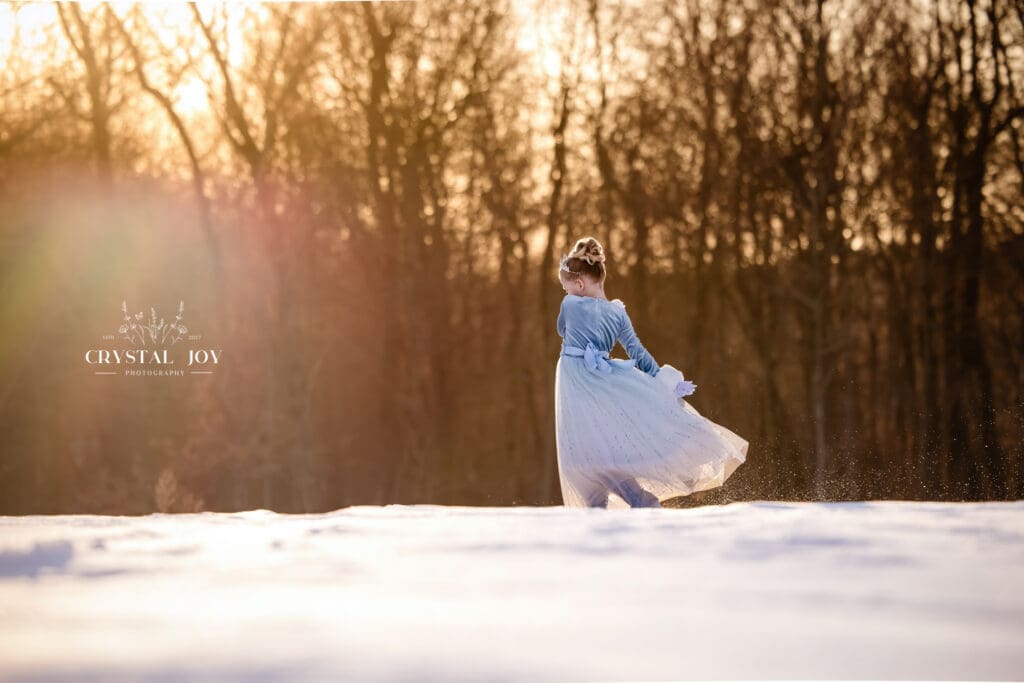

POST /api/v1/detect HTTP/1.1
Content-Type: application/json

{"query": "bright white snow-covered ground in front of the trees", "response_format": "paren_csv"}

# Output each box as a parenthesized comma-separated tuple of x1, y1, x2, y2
(0, 501, 1024, 681)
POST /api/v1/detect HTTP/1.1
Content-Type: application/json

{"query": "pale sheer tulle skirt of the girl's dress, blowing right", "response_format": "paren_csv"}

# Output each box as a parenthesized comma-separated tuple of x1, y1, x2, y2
(555, 355, 748, 508)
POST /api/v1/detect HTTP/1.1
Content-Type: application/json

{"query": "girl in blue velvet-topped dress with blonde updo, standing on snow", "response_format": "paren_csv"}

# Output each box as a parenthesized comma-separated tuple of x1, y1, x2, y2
(555, 238, 748, 508)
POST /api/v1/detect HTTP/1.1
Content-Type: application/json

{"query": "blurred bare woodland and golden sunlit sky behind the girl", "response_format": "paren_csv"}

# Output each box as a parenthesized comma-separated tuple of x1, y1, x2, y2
(0, 0, 1024, 514)
